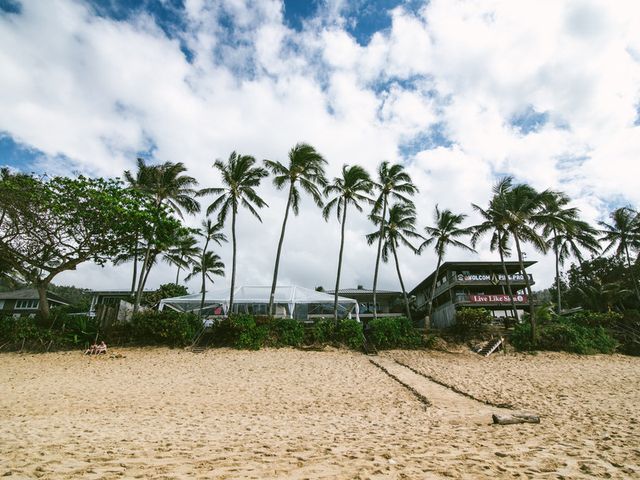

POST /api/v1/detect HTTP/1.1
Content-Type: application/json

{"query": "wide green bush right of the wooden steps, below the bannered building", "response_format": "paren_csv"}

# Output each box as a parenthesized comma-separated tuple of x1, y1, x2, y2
(511, 317, 618, 354)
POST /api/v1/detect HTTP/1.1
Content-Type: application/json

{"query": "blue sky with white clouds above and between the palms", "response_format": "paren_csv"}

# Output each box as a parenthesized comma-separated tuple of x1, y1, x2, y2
(0, 0, 640, 292)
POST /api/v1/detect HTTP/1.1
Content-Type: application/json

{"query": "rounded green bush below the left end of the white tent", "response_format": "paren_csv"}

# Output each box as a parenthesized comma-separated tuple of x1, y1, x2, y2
(131, 310, 202, 347)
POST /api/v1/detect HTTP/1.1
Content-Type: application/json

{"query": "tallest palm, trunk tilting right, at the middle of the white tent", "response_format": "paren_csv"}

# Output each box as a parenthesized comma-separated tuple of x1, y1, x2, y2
(264, 143, 327, 315)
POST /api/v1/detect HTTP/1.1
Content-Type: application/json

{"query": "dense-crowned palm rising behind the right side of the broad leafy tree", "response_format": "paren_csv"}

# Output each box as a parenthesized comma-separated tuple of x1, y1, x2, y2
(124, 158, 200, 311)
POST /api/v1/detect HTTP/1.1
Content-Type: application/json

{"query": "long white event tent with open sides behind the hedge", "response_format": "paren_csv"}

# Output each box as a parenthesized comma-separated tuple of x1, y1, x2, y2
(159, 285, 360, 321)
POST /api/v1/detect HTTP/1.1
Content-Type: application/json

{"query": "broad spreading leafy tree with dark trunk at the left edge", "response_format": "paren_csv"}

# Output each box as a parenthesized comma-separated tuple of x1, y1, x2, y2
(0, 174, 179, 321)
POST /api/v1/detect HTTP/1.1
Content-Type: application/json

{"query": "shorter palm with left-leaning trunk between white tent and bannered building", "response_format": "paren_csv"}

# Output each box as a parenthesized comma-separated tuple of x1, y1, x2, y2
(367, 203, 424, 320)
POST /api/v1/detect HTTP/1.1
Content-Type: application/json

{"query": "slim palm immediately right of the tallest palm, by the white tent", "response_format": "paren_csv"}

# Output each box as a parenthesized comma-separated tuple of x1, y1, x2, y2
(322, 165, 373, 322)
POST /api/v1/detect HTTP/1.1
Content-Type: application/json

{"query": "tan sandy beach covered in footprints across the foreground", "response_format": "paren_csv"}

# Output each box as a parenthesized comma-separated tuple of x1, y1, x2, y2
(0, 348, 640, 479)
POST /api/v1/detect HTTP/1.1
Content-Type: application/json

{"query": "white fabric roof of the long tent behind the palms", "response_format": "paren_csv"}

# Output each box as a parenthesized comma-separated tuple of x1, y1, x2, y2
(161, 285, 357, 305)
